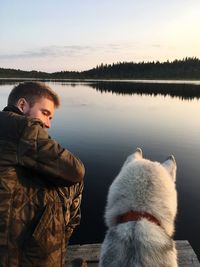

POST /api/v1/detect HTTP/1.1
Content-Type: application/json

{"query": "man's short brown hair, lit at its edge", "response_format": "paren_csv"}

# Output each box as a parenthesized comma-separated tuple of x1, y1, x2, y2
(8, 82, 60, 108)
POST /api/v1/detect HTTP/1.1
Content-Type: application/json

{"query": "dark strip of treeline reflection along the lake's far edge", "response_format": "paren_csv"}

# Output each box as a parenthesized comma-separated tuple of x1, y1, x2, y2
(0, 78, 200, 99)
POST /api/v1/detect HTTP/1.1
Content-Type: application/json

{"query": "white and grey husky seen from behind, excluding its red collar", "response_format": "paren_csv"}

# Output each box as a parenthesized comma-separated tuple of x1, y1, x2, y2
(99, 148, 178, 267)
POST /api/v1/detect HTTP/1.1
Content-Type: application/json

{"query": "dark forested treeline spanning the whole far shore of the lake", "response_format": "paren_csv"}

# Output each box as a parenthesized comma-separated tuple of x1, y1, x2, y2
(0, 57, 200, 80)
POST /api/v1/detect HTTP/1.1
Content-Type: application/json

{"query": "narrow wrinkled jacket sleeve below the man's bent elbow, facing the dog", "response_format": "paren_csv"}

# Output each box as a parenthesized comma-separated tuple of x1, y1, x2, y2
(65, 182, 83, 243)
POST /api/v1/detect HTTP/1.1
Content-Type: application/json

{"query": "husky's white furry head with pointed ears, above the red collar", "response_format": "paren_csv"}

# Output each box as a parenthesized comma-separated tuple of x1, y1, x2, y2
(105, 148, 177, 235)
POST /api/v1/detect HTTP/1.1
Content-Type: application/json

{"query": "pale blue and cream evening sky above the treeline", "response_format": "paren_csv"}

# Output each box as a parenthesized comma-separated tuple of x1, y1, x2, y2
(0, 0, 200, 72)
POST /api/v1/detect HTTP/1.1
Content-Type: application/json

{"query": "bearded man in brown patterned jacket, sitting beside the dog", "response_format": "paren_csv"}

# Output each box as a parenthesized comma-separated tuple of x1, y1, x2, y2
(0, 82, 85, 267)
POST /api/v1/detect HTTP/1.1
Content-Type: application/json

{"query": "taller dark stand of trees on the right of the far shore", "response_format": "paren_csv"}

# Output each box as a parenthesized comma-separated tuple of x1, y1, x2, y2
(84, 58, 200, 79)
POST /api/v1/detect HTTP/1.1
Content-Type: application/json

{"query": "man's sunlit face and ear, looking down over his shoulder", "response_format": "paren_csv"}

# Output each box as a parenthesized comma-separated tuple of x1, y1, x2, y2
(20, 97, 55, 128)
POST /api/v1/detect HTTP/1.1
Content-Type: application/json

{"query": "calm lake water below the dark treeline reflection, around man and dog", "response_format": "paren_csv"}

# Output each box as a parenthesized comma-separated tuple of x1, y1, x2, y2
(0, 81, 200, 260)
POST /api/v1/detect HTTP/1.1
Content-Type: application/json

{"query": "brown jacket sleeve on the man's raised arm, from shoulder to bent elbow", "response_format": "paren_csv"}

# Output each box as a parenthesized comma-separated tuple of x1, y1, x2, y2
(17, 119, 85, 186)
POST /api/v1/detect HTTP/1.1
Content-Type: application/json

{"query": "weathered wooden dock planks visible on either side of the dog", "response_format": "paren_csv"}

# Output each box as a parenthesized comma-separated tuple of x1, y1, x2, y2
(66, 240, 200, 267)
